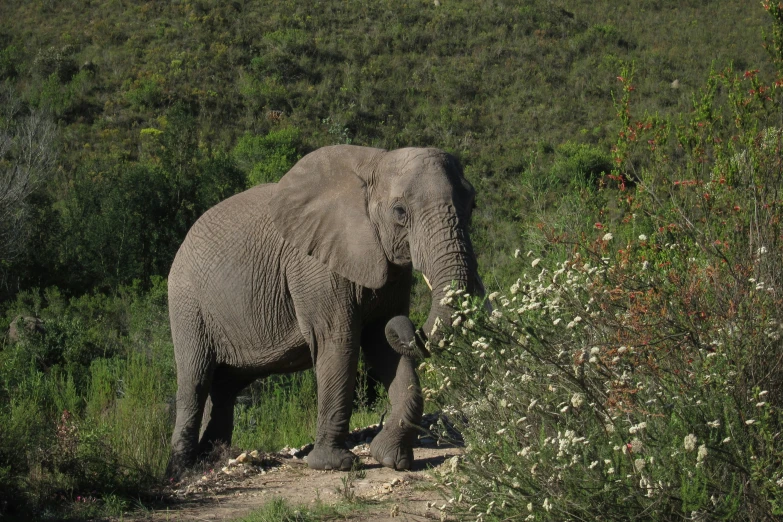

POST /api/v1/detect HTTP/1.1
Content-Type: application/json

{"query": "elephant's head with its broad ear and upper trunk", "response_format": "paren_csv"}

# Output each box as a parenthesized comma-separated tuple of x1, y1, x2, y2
(271, 145, 484, 340)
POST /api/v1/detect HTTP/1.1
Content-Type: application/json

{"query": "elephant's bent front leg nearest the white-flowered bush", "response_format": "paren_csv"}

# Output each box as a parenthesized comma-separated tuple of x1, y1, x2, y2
(365, 318, 424, 470)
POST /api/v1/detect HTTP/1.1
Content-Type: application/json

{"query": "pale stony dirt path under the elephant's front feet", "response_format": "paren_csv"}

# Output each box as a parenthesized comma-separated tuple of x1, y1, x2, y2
(122, 418, 462, 522)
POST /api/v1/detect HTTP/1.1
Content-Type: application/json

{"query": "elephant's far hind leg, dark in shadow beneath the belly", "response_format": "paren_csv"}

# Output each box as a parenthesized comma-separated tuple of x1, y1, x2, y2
(198, 367, 255, 455)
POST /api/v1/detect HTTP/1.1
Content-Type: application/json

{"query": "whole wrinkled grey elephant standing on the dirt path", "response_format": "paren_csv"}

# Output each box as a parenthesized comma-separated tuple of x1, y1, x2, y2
(167, 145, 483, 476)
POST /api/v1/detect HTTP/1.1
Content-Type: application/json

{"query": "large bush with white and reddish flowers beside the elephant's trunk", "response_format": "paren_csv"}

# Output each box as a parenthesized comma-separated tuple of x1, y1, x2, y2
(422, 17, 783, 520)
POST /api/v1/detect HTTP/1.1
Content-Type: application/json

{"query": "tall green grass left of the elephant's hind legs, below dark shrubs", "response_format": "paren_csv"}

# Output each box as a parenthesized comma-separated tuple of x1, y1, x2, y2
(0, 278, 176, 519)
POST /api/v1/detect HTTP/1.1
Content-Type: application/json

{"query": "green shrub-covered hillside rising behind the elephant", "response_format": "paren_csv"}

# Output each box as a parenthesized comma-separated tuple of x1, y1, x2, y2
(0, 1, 768, 294)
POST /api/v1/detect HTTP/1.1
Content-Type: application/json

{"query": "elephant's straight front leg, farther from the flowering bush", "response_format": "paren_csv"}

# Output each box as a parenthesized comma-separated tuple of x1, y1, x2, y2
(307, 340, 359, 471)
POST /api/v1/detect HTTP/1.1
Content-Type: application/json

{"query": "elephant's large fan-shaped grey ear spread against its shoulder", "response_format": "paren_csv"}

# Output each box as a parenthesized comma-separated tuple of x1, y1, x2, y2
(270, 145, 389, 288)
